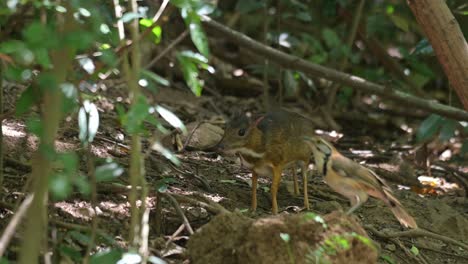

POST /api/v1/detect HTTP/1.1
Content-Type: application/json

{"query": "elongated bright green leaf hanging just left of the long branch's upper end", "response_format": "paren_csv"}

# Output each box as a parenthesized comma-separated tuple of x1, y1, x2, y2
(181, 9, 210, 57)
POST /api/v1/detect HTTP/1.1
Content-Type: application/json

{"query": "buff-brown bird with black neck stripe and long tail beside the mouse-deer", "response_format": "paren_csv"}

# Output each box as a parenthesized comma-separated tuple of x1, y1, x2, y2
(305, 136, 418, 228)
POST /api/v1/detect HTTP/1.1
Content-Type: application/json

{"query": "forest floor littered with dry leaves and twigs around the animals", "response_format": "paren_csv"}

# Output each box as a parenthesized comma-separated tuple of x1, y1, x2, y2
(0, 81, 468, 263)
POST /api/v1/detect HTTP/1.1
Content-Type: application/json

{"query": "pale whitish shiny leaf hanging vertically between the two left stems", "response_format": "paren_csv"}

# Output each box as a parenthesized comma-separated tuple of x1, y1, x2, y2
(78, 100, 99, 145)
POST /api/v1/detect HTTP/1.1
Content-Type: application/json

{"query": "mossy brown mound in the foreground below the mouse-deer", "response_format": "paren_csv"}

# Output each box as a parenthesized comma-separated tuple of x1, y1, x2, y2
(187, 212, 378, 264)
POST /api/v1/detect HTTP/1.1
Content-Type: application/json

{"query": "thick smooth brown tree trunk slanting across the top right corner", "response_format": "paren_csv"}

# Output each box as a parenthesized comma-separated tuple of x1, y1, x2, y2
(408, 0, 468, 110)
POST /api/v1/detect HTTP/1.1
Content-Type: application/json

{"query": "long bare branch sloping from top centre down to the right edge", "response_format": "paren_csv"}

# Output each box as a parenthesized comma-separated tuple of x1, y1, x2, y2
(202, 16, 468, 121)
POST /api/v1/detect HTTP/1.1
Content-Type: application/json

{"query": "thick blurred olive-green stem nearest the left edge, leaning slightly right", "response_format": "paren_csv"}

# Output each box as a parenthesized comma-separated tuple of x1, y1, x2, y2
(18, 6, 75, 264)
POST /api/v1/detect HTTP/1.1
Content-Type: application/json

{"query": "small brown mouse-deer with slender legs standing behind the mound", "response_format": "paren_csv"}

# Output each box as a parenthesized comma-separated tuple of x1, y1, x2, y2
(217, 110, 314, 214)
